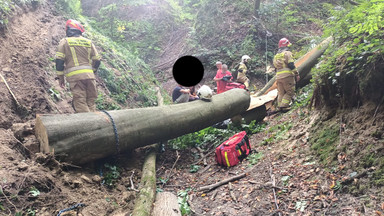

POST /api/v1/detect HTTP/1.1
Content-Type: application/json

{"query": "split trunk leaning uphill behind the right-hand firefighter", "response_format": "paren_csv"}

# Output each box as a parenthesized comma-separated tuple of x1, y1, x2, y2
(256, 37, 333, 96)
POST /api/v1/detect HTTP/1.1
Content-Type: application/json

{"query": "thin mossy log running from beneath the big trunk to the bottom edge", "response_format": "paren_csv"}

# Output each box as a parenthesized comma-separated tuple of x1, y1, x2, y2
(132, 145, 158, 216)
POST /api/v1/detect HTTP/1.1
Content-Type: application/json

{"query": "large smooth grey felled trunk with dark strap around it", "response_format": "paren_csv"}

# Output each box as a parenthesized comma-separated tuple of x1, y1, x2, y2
(35, 89, 250, 164)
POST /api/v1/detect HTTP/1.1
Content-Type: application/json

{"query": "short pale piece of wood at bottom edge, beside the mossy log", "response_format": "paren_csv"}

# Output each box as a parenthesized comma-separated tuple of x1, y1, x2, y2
(152, 192, 181, 216)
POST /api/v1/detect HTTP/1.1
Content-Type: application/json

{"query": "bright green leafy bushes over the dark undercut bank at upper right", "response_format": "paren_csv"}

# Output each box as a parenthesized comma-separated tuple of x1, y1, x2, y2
(314, 0, 384, 107)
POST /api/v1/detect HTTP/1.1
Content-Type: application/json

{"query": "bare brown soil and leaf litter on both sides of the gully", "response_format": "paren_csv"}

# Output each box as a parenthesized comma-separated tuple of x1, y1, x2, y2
(0, 2, 384, 216)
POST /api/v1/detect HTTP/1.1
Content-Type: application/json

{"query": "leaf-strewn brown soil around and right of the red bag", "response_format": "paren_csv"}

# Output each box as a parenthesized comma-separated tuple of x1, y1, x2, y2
(159, 105, 384, 215)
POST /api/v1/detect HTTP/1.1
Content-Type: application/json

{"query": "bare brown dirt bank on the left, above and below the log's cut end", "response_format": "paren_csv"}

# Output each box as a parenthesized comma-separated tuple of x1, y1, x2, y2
(0, 1, 146, 216)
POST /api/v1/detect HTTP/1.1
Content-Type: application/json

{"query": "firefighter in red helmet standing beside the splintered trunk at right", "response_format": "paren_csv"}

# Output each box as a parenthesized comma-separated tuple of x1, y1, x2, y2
(273, 38, 300, 111)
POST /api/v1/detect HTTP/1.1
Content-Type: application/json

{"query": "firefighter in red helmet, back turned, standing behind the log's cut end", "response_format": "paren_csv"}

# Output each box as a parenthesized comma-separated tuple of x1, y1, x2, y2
(56, 19, 100, 113)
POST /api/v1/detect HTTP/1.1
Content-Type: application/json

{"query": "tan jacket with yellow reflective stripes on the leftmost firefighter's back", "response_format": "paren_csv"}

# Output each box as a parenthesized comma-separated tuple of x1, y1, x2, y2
(56, 36, 100, 82)
